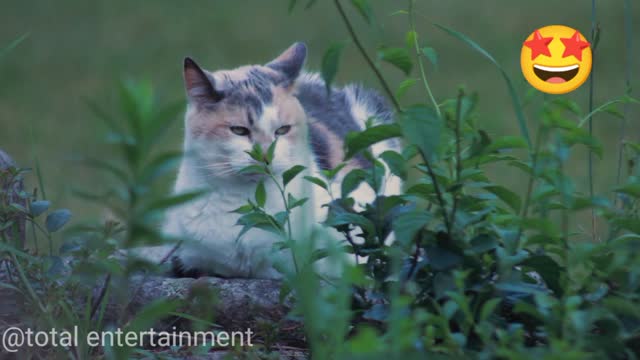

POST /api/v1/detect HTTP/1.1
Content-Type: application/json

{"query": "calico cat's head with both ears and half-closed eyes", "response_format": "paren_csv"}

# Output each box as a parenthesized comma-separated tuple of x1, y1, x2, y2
(184, 43, 308, 181)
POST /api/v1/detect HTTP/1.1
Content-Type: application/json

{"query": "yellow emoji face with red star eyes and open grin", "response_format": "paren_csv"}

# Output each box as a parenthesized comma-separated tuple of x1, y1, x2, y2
(520, 25, 591, 94)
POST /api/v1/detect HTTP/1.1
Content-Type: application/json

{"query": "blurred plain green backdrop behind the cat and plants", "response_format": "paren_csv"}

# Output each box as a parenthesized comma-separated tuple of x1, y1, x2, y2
(0, 0, 640, 219)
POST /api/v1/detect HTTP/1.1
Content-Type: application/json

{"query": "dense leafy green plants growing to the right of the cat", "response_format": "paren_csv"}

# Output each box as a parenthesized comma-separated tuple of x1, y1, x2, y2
(278, 1, 640, 359)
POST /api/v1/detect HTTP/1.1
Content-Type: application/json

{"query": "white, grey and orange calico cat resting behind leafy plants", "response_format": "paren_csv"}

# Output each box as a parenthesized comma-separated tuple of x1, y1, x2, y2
(139, 42, 402, 279)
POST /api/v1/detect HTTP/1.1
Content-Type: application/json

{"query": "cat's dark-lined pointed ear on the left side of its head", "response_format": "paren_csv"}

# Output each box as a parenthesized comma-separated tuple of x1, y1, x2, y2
(184, 57, 223, 105)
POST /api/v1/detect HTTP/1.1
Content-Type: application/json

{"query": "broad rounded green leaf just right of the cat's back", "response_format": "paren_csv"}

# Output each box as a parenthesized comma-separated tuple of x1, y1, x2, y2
(400, 106, 442, 159)
